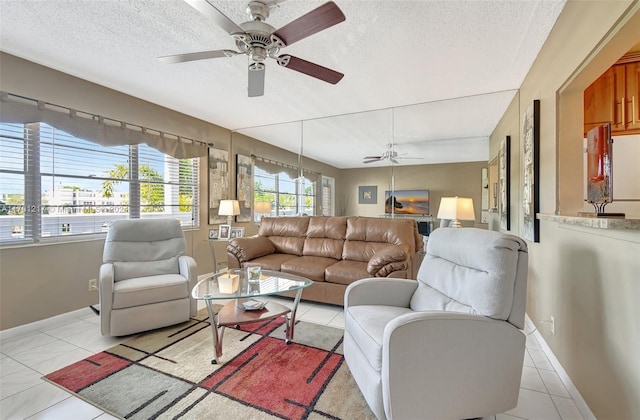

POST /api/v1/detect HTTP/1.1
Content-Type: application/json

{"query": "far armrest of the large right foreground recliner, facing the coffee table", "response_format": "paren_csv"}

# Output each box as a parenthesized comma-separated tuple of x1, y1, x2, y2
(344, 278, 418, 310)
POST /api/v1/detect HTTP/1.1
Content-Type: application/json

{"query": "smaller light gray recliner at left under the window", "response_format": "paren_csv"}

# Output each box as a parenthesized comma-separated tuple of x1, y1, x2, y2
(99, 219, 197, 336)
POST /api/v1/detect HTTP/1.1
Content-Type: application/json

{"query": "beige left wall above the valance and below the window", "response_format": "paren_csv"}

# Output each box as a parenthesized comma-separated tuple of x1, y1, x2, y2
(0, 53, 340, 330)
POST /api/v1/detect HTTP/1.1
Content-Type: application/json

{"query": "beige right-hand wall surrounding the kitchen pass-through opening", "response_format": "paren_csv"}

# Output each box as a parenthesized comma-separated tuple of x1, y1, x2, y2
(490, 1, 640, 419)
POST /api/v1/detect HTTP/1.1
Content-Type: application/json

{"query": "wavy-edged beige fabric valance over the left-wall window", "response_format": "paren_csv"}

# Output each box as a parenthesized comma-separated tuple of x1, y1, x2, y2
(0, 92, 209, 159)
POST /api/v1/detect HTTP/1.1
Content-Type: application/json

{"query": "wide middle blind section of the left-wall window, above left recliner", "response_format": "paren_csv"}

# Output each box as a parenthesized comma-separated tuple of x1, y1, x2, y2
(38, 124, 130, 238)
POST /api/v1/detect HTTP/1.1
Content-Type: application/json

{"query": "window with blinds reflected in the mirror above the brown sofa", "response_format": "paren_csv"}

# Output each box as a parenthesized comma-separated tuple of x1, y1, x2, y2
(253, 159, 316, 222)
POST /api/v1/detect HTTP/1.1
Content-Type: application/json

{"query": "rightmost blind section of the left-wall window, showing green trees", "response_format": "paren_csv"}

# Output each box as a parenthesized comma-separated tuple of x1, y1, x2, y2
(138, 144, 198, 226)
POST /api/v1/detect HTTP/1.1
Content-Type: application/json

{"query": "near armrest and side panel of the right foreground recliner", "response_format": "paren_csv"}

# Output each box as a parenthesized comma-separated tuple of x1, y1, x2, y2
(382, 311, 526, 418)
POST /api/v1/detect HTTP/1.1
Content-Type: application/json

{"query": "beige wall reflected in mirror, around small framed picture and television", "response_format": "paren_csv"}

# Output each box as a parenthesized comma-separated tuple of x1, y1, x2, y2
(338, 162, 488, 227)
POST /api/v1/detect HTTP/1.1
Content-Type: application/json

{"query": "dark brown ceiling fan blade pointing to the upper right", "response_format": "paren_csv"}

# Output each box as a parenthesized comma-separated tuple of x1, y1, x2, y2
(272, 0, 346, 47)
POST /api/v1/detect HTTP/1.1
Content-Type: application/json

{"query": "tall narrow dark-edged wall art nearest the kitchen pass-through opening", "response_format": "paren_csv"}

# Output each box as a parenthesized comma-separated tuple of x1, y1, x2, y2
(522, 99, 540, 242)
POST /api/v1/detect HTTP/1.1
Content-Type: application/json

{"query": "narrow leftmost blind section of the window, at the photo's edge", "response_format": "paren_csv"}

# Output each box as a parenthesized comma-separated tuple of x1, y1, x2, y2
(0, 124, 33, 241)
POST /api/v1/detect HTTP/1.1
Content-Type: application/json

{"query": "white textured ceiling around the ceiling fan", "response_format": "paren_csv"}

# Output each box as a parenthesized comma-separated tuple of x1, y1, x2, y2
(0, 0, 564, 168)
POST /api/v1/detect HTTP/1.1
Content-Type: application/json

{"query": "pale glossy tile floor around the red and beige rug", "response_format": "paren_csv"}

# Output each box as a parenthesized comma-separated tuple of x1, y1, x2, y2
(0, 300, 583, 420)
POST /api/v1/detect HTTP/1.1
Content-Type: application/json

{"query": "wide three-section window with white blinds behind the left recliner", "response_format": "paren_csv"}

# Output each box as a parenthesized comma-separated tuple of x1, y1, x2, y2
(0, 123, 199, 243)
